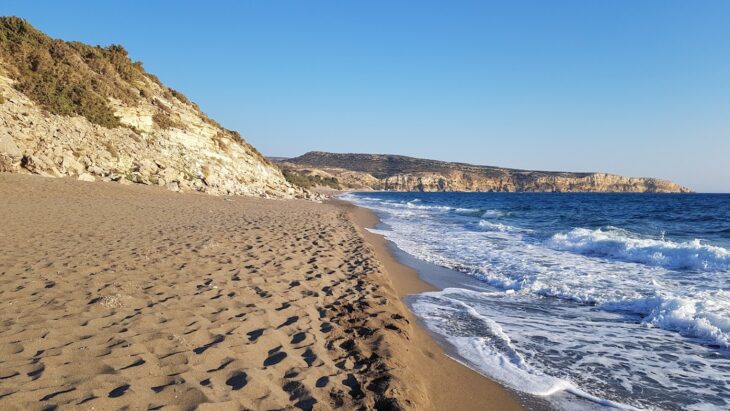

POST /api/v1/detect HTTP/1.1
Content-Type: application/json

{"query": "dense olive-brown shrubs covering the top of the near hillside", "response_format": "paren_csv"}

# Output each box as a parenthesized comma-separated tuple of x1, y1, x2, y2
(0, 17, 152, 128)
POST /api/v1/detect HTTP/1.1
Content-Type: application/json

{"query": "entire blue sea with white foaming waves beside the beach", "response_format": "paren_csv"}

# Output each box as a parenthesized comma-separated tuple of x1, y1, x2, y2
(343, 192, 730, 410)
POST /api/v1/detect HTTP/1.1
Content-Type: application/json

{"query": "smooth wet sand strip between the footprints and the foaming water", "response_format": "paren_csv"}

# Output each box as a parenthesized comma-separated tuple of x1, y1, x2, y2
(330, 200, 523, 410)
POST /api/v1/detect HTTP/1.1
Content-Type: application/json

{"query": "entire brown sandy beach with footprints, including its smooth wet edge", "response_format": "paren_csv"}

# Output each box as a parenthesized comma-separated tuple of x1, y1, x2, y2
(0, 174, 518, 410)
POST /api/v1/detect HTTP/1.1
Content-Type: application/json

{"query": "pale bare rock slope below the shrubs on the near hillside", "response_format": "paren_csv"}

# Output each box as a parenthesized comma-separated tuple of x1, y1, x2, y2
(0, 76, 310, 198)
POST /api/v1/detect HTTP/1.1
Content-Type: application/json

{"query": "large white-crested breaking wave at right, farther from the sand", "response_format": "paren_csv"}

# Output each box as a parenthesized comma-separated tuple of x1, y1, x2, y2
(547, 227, 730, 271)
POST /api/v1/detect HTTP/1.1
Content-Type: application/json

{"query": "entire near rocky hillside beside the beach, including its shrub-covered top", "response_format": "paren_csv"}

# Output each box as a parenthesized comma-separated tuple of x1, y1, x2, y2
(0, 17, 309, 198)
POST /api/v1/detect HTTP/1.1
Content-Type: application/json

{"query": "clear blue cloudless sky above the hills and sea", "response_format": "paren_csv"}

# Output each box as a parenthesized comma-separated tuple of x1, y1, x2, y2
(0, 0, 730, 192)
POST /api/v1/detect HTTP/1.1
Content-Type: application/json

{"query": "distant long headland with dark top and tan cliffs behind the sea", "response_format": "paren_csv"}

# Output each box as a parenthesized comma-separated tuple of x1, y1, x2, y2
(278, 151, 691, 193)
